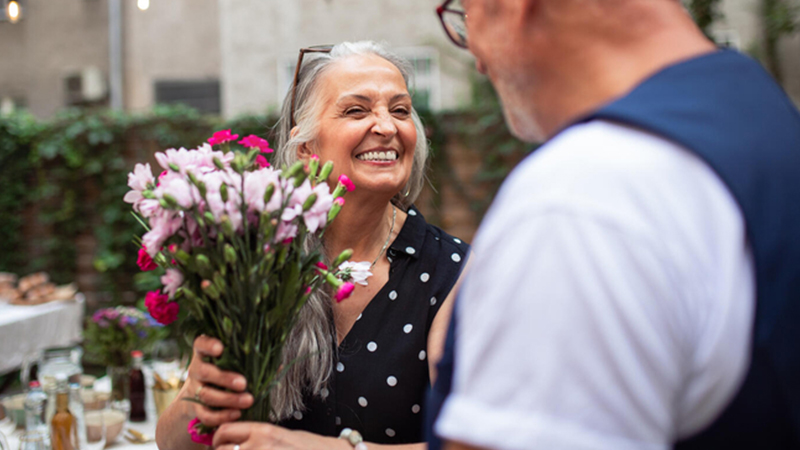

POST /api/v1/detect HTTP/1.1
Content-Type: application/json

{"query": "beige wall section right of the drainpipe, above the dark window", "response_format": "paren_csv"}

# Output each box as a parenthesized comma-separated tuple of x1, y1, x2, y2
(123, 0, 220, 111)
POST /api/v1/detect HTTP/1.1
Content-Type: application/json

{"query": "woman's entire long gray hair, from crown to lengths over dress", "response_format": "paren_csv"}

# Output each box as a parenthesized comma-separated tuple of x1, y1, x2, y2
(271, 41, 428, 421)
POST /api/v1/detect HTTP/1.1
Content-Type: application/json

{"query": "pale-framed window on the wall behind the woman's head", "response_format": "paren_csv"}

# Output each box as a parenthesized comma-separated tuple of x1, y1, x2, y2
(278, 47, 442, 111)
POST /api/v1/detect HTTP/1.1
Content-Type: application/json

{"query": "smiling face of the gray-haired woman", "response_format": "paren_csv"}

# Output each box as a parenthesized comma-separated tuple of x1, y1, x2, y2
(299, 55, 417, 197)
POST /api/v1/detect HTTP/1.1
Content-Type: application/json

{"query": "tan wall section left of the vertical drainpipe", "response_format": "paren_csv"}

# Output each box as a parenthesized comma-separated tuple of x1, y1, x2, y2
(0, 0, 108, 117)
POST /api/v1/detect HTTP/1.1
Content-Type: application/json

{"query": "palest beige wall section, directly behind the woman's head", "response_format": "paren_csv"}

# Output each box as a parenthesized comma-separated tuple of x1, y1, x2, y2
(219, 0, 472, 117)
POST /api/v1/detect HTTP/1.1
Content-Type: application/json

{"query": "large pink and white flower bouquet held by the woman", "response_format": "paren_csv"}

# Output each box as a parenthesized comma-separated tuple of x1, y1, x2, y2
(125, 130, 359, 428)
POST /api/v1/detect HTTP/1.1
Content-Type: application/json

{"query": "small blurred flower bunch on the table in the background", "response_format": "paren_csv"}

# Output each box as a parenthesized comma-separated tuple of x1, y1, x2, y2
(83, 306, 161, 367)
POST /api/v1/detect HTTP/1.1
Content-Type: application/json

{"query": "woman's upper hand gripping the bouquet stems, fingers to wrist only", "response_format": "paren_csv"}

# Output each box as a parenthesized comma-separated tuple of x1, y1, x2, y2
(184, 336, 253, 427)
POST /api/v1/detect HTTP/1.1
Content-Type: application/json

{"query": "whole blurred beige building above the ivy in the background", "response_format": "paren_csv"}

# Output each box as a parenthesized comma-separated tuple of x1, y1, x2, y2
(0, 0, 800, 118)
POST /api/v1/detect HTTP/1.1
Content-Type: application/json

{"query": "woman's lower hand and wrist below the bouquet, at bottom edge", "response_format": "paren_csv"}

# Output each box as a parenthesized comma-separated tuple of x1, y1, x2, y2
(214, 422, 352, 450)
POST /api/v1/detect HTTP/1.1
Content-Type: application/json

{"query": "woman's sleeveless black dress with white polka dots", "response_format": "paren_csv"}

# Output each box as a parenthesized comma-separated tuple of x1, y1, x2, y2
(281, 208, 469, 444)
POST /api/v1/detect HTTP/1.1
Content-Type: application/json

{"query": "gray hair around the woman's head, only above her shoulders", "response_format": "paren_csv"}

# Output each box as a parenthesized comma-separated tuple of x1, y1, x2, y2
(275, 41, 428, 209)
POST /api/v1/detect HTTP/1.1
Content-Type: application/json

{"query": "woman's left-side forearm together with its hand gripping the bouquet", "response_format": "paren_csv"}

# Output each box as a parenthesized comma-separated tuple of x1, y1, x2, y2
(156, 336, 253, 450)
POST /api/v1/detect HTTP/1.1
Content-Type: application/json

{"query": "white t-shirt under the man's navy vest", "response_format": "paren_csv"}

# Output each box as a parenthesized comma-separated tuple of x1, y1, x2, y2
(437, 121, 755, 450)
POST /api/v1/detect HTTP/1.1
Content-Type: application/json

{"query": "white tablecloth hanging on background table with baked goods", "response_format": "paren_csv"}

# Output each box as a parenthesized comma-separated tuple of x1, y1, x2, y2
(0, 294, 85, 375)
